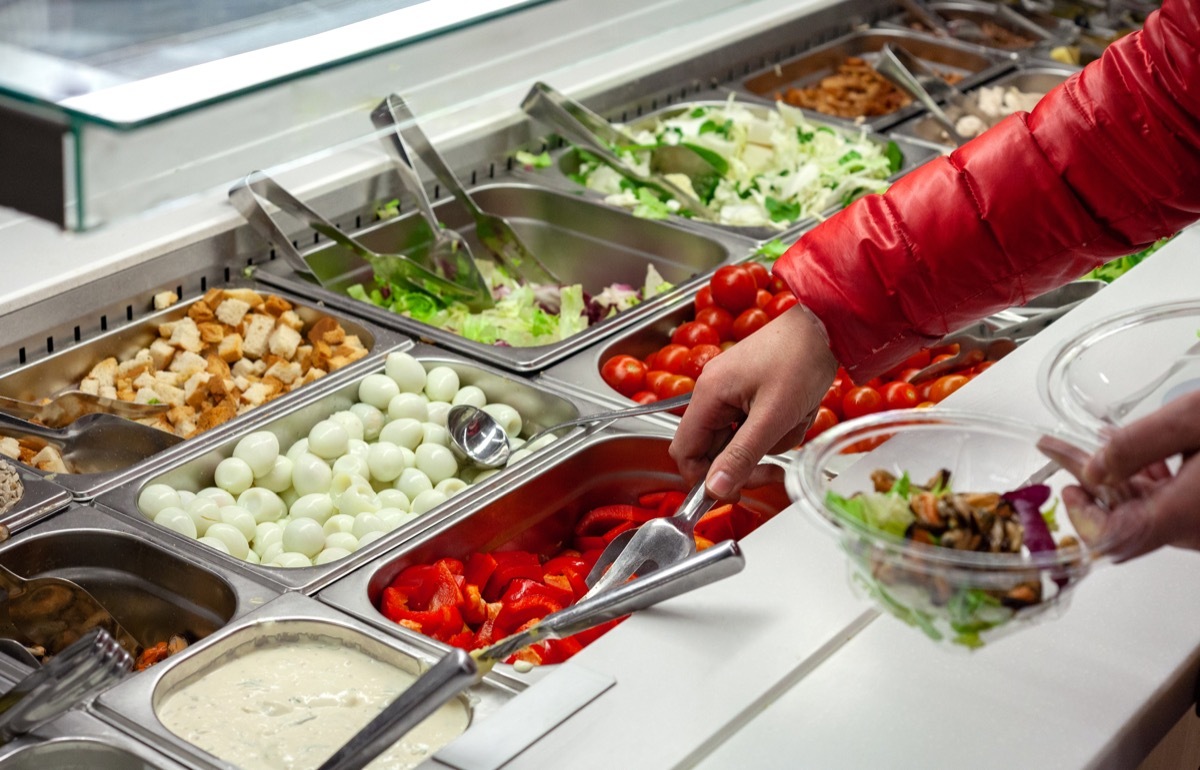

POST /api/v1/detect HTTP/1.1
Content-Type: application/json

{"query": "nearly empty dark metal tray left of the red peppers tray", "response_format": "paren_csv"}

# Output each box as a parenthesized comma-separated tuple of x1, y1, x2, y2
(0, 505, 278, 668)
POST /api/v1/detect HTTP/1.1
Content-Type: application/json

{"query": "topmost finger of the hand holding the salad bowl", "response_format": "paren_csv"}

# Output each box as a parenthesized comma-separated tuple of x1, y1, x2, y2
(1081, 391, 1200, 485)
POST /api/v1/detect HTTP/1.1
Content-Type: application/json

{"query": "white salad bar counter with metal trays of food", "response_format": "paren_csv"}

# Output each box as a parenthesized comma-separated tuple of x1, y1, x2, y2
(0, 0, 1200, 770)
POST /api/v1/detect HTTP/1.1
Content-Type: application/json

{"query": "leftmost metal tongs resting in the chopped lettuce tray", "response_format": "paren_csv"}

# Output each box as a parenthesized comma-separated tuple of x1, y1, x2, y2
(229, 172, 491, 309)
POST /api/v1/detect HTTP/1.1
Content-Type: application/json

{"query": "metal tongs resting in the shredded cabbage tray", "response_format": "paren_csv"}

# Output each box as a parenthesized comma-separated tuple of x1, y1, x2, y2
(521, 83, 719, 219)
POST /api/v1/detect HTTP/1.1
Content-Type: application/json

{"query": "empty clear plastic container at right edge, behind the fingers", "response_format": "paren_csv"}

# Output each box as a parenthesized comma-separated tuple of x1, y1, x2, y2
(1038, 301, 1200, 435)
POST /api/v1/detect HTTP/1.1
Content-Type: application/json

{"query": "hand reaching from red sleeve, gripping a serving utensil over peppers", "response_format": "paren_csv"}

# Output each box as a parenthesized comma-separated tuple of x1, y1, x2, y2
(671, 306, 838, 500)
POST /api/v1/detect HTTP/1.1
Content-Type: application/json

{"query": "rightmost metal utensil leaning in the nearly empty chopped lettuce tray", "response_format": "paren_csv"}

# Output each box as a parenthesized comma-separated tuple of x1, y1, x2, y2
(380, 94, 563, 284)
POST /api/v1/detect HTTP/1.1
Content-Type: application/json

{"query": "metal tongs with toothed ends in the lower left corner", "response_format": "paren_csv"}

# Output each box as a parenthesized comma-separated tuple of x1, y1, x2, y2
(0, 628, 133, 744)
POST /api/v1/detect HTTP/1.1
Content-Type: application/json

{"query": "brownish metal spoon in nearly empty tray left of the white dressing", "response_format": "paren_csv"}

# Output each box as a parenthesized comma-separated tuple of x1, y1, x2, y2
(0, 566, 140, 655)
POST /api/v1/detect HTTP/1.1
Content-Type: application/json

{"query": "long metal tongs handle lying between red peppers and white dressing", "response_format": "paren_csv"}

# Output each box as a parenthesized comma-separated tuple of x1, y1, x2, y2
(318, 540, 745, 770)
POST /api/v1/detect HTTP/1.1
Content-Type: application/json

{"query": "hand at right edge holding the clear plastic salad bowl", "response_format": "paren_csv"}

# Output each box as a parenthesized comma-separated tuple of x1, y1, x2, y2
(1039, 392, 1200, 561)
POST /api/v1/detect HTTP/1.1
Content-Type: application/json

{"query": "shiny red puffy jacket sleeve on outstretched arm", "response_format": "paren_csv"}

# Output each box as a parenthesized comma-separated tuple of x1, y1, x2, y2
(775, 0, 1200, 381)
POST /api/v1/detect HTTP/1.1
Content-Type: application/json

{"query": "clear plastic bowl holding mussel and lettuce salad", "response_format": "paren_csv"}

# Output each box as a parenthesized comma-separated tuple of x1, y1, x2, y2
(787, 409, 1103, 648)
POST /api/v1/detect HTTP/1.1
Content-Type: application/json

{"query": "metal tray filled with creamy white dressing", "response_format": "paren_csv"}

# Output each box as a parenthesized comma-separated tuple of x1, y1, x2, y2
(88, 592, 515, 770)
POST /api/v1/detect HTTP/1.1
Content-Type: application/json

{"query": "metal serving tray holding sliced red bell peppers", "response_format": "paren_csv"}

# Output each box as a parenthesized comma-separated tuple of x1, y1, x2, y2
(317, 431, 791, 675)
